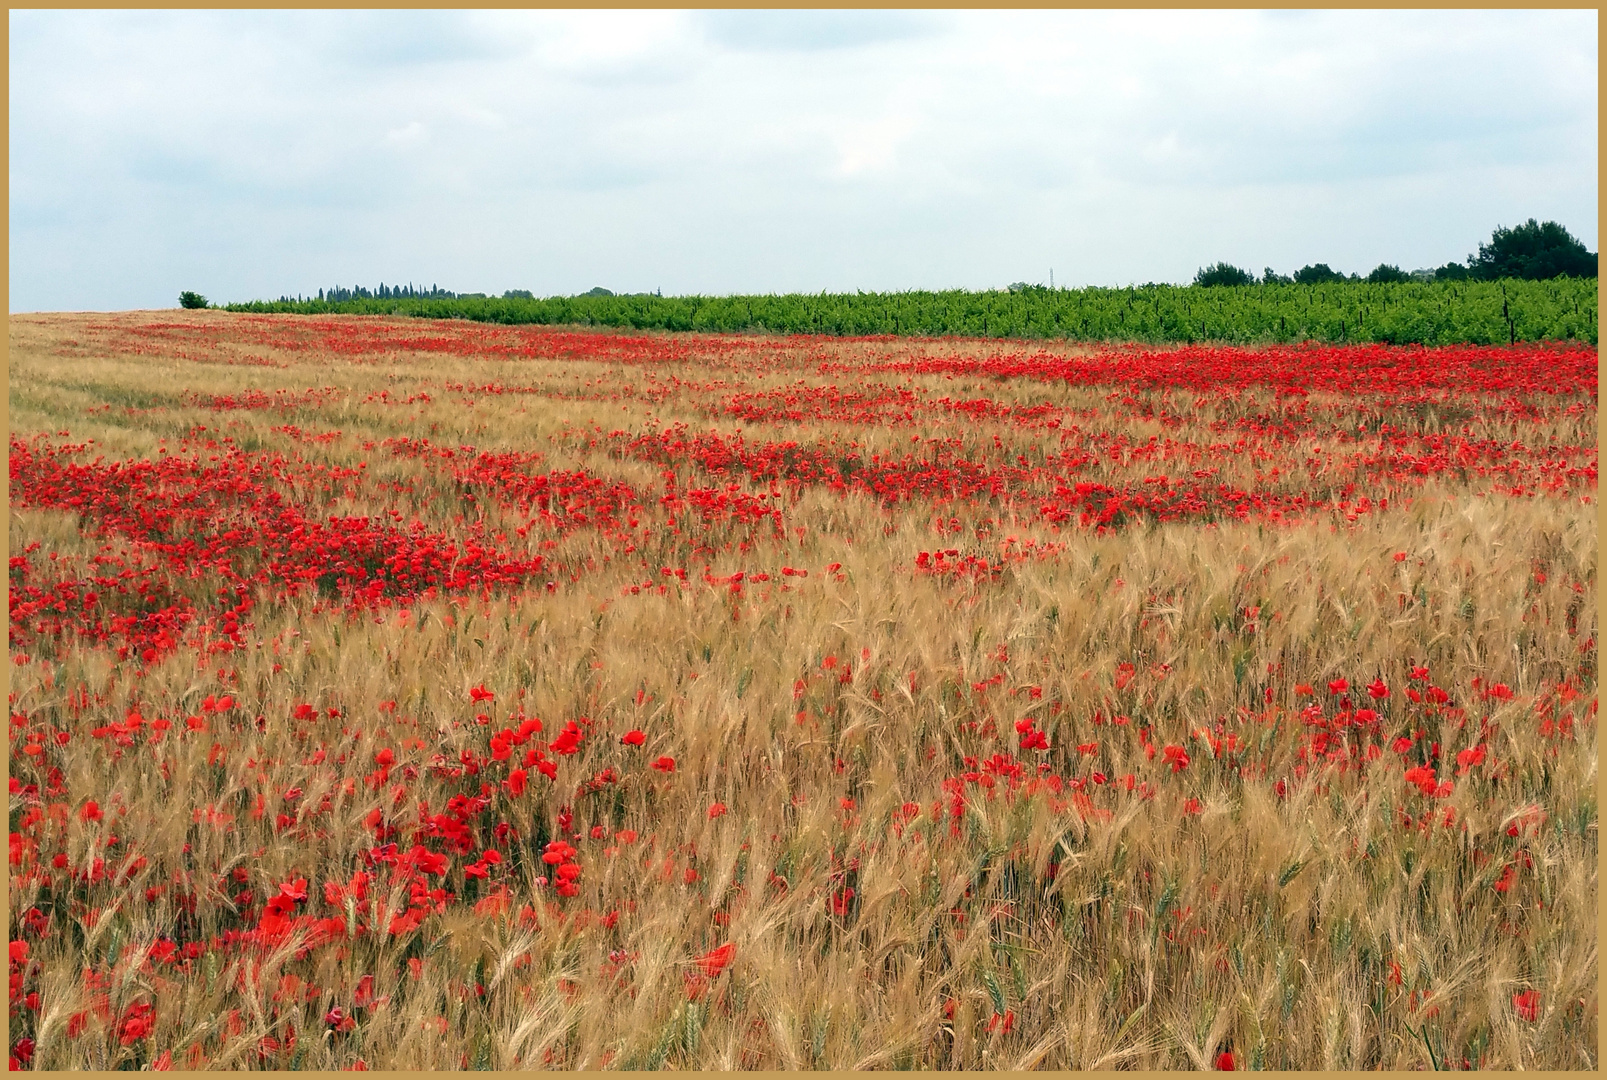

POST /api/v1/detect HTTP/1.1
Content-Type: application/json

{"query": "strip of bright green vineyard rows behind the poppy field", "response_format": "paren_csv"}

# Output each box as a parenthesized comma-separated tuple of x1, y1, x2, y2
(227, 278, 1597, 346)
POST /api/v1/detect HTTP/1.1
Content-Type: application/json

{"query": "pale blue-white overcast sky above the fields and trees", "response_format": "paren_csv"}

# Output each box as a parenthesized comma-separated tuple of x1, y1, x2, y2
(10, 11, 1597, 312)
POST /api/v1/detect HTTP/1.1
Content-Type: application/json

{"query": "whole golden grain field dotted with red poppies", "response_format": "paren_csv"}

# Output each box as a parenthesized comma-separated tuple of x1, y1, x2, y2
(8, 310, 1599, 1069)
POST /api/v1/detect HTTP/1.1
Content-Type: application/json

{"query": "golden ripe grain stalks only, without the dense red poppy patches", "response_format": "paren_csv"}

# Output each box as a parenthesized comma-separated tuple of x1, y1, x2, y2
(10, 313, 1597, 1069)
